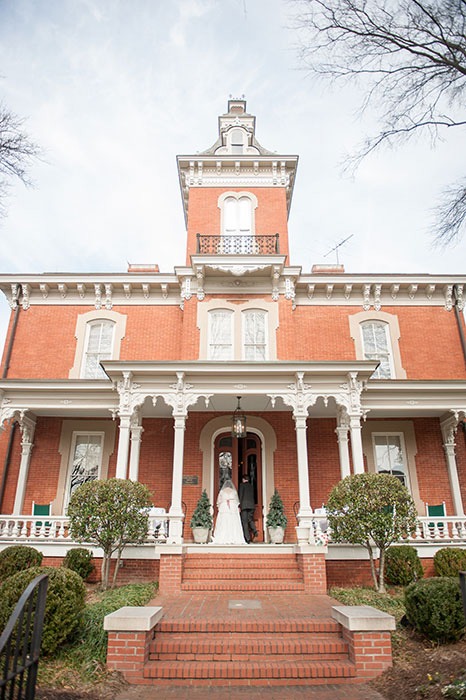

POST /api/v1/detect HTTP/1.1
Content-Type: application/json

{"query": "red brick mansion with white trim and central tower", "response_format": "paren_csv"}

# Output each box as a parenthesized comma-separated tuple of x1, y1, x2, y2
(0, 99, 466, 582)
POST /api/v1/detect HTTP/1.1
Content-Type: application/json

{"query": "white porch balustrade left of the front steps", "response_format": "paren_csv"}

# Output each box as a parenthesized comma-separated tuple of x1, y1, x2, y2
(0, 513, 170, 544)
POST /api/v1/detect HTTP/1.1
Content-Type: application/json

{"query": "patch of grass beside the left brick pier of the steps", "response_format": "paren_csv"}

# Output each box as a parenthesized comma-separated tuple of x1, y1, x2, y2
(38, 583, 157, 689)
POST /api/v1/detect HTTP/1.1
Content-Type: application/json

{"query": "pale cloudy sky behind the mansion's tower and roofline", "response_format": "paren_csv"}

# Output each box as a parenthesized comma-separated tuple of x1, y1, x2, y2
(0, 0, 466, 350)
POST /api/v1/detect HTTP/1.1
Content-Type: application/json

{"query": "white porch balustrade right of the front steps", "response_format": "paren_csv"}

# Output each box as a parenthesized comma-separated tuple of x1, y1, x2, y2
(313, 515, 466, 544)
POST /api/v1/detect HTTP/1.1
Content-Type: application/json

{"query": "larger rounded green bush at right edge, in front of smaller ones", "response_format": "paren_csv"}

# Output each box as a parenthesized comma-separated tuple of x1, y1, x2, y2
(405, 577, 464, 642)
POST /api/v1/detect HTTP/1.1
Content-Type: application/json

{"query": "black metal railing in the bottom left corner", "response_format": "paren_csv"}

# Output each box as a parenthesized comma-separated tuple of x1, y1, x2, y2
(0, 574, 49, 700)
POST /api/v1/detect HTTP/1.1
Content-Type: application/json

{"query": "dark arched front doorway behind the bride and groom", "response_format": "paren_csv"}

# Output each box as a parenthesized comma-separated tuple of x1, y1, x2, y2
(214, 432, 264, 542)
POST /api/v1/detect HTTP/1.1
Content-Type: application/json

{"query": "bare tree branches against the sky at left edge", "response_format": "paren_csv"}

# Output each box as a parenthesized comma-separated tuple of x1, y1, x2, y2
(0, 103, 40, 216)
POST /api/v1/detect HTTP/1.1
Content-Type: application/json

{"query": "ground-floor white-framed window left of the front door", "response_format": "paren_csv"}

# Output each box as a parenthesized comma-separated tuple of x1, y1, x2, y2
(66, 432, 104, 503)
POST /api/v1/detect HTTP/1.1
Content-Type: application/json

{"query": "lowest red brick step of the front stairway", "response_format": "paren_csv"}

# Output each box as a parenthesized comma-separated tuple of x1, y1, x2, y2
(144, 660, 356, 685)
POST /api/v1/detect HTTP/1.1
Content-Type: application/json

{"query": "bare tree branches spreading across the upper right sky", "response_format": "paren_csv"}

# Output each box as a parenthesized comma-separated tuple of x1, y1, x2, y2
(294, 0, 466, 245)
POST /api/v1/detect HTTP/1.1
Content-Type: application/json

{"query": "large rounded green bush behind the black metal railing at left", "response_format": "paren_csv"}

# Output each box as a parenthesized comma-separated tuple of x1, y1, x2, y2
(0, 566, 85, 655)
